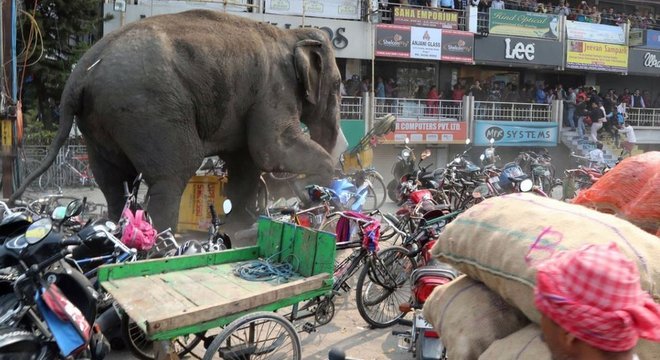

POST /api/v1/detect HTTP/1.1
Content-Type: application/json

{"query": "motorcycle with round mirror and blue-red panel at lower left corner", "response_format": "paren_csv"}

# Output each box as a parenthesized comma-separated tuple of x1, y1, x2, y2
(0, 200, 109, 360)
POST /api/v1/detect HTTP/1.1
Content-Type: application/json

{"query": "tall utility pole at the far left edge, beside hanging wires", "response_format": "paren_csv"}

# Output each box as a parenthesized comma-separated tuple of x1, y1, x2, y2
(0, 0, 17, 198)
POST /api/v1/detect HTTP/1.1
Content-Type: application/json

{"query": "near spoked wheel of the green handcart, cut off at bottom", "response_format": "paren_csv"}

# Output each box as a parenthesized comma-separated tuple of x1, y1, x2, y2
(203, 311, 302, 360)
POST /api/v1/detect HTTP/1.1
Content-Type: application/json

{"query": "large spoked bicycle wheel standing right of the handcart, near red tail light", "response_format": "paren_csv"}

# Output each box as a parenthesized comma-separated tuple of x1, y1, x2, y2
(355, 246, 417, 329)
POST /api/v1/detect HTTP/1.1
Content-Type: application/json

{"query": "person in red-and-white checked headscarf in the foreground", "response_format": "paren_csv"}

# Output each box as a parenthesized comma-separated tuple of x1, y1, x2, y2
(534, 243, 660, 360)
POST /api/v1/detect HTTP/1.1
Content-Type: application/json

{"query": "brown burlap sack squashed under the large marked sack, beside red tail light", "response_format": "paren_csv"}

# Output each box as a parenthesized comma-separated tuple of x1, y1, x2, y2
(423, 275, 529, 360)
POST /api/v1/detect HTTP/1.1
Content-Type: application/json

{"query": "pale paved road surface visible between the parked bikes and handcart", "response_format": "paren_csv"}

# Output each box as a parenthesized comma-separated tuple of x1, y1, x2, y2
(24, 189, 412, 360)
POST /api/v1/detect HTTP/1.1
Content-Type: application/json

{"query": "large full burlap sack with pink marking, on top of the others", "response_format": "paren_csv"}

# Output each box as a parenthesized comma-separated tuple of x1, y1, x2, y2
(431, 194, 660, 323)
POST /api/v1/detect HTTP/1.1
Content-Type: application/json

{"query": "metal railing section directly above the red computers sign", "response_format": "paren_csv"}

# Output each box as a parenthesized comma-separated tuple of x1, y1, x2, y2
(374, 98, 463, 121)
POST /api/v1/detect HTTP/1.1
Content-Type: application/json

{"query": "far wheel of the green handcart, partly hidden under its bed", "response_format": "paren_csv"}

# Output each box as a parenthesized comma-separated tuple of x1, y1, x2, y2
(121, 314, 204, 360)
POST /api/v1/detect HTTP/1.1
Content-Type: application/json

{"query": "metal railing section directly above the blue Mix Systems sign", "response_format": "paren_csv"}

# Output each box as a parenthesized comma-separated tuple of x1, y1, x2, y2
(474, 101, 552, 122)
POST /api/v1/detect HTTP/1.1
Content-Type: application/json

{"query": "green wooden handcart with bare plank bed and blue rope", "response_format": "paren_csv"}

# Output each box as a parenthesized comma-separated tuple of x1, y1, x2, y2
(98, 218, 336, 360)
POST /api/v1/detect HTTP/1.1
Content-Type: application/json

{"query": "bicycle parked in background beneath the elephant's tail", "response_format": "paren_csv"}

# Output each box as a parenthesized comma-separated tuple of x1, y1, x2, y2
(38, 147, 96, 191)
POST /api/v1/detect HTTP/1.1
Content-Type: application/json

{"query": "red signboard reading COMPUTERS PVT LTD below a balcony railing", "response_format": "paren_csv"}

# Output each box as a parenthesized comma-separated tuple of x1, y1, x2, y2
(383, 117, 467, 144)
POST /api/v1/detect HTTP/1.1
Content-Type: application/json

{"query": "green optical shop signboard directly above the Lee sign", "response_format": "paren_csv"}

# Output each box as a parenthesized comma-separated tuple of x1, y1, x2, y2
(489, 9, 559, 40)
